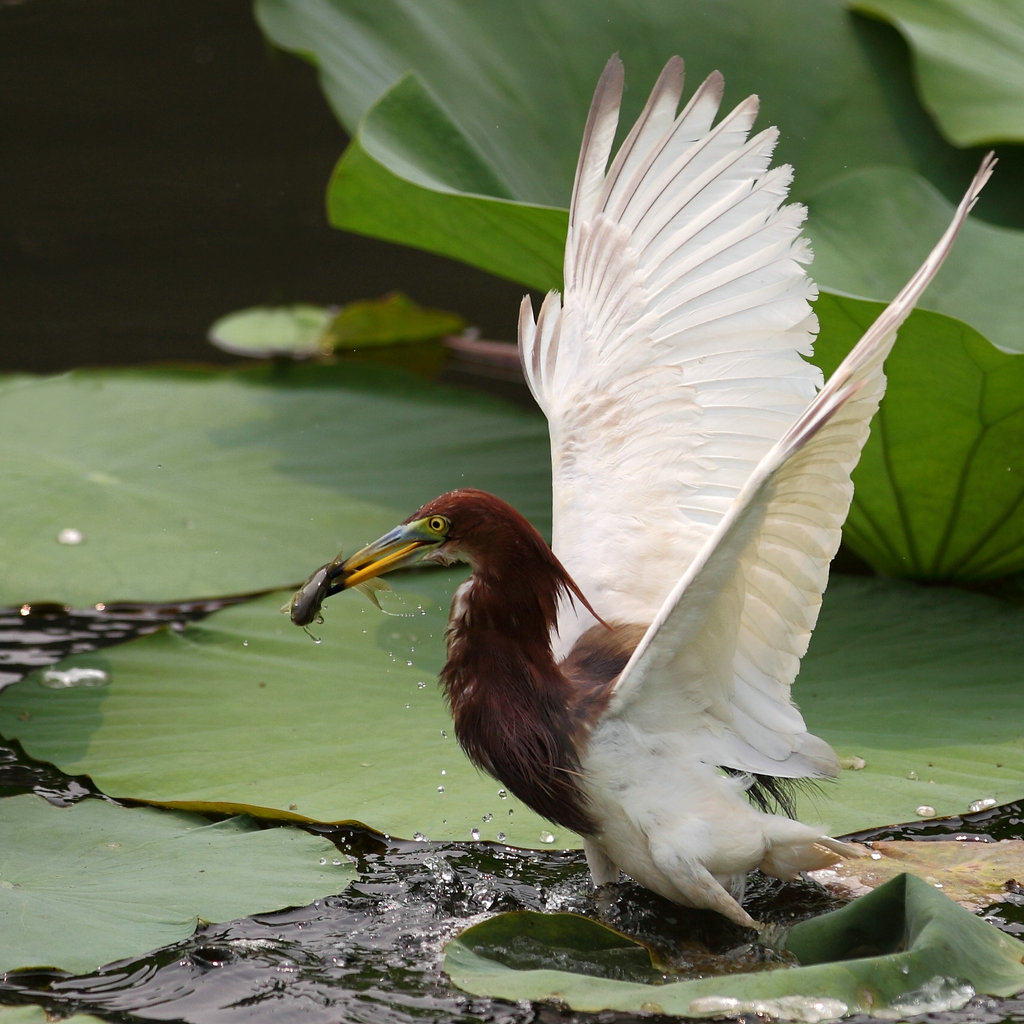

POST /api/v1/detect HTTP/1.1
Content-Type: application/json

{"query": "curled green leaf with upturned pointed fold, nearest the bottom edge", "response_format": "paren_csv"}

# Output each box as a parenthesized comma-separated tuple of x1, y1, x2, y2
(444, 874, 1024, 1021)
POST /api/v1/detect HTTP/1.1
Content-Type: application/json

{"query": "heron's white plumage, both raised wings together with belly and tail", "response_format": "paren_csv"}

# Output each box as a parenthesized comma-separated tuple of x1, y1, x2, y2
(519, 51, 994, 925)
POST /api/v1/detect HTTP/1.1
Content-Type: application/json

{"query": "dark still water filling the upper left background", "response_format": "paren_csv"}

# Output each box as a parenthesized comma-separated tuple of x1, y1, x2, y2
(0, 0, 523, 372)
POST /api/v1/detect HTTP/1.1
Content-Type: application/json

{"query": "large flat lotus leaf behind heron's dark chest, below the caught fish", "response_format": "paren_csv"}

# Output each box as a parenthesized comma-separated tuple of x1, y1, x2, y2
(0, 577, 1024, 848)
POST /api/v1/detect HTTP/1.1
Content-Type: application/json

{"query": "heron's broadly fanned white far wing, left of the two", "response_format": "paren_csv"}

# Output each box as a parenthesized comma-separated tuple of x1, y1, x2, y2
(519, 57, 820, 651)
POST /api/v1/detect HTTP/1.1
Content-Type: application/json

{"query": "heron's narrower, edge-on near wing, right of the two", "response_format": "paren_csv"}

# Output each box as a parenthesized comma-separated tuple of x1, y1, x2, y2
(608, 154, 995, 777)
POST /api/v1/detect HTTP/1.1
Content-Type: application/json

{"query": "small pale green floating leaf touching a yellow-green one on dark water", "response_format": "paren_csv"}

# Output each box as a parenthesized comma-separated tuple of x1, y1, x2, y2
(209, 305, 331, 359)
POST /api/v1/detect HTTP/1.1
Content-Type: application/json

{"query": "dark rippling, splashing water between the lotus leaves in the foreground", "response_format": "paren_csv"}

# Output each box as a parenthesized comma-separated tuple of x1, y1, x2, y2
(0, 602, 1024, 1024)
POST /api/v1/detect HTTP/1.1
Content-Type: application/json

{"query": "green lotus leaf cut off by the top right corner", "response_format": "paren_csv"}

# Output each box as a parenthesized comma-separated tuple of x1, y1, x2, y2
(850, 0, 1024, 145)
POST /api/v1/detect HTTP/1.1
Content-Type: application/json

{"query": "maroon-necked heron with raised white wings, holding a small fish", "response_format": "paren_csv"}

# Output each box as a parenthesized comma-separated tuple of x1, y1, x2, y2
(291, 57, 994, 928)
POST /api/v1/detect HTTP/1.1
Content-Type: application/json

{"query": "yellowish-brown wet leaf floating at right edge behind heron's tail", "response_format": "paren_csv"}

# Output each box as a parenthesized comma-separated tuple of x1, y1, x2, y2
(812, 840, 1024, 911)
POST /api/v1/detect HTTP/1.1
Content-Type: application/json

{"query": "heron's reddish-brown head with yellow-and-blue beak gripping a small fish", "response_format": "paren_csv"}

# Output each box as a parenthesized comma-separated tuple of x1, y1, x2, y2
(289, 487, 561, 626)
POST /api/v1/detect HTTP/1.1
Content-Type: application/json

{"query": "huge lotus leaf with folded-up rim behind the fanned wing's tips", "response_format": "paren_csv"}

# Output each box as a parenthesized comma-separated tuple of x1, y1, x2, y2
(256, 0, 1024, 292)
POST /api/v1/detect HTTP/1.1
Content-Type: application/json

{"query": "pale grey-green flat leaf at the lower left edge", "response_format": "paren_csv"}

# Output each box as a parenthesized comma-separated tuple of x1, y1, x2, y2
(0, 794, 355, 974)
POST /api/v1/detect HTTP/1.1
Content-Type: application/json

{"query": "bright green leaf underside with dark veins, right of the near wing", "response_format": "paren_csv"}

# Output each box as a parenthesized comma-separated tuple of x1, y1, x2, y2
(815, 295, 1024, 581)
